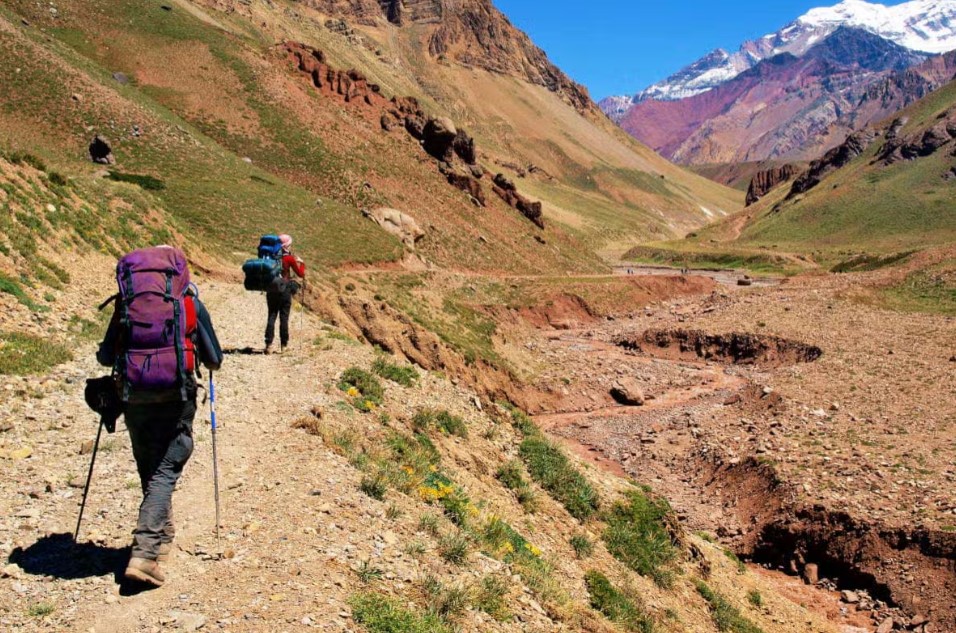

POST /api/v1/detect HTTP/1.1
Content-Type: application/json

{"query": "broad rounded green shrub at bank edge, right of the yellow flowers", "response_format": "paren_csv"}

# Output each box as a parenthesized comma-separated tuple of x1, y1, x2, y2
(604, 490, 679, 588)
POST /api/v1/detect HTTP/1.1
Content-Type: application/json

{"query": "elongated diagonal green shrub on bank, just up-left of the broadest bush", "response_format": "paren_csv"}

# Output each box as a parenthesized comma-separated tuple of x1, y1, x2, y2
(518, 435, 600, 521)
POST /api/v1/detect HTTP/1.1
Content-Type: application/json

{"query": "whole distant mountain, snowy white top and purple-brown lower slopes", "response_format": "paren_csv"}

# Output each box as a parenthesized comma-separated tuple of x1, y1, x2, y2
(600, 0, 956, 165)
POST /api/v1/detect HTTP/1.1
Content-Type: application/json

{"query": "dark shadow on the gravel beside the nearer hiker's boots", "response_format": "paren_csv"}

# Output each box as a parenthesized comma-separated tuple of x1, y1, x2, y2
(9, 533, 161, 596)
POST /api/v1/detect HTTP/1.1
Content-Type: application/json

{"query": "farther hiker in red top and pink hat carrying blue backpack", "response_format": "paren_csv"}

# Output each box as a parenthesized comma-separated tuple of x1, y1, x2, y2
(242, 235, 305, 354)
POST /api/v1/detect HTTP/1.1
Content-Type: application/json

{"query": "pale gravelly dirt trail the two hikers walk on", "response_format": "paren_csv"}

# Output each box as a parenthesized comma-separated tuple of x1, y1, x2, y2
(0, 283, 380, 633)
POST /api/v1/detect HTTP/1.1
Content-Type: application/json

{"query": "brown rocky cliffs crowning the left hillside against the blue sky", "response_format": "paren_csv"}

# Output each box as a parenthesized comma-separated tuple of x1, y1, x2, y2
(299, 0, 598, 115)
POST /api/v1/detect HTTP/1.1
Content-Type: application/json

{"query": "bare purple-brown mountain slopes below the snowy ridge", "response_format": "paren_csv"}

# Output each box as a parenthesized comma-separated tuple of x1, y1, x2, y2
(621, 28, 956, 164)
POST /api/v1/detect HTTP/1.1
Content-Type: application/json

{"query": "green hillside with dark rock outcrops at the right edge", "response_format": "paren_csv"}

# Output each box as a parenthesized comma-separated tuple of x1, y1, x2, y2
(700, 74, 956, 260)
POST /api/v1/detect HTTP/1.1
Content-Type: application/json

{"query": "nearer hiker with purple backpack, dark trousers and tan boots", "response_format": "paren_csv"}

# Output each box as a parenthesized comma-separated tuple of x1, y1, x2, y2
(96, 246, 223, 587)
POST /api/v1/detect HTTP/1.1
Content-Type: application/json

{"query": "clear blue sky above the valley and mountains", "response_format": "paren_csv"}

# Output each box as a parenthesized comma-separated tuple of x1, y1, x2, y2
(494, 0, 901, 100)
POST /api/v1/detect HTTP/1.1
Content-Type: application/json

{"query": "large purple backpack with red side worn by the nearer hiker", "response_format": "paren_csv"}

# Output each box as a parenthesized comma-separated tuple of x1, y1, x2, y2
(116, 246, 196, 400)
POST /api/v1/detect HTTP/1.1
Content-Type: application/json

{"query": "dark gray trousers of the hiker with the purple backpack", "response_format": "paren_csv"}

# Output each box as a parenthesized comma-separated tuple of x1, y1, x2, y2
(126, 398, 196, 560)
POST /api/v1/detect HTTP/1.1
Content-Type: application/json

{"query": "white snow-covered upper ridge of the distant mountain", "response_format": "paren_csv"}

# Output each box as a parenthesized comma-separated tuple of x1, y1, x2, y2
(602, 0, 956, 109)
